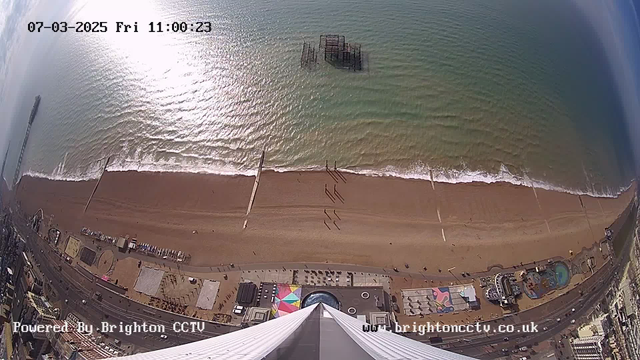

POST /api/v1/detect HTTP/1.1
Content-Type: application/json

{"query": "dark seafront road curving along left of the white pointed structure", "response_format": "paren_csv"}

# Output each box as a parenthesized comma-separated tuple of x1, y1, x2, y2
(13, 220, 239, 350)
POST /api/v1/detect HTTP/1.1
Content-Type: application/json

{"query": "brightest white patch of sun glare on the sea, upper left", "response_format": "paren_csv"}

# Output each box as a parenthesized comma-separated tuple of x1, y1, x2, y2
(69, 0, 240, 146)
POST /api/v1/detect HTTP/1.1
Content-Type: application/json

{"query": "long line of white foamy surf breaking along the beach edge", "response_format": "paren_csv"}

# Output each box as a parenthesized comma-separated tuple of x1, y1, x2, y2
(17, 156, 632, 198)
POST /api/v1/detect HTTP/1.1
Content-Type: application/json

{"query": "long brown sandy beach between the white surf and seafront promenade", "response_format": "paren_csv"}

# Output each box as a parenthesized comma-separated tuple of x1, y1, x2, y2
(13, 171, 635, 273)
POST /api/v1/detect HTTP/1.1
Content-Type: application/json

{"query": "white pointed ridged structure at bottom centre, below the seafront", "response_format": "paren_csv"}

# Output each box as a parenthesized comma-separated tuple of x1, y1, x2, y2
(110, 303, 472, 360)
